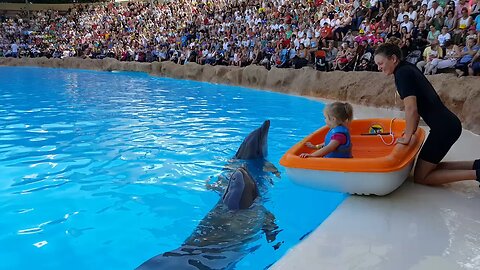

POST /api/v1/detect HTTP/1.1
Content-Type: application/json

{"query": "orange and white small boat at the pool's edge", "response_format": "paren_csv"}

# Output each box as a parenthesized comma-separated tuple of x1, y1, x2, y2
(280, 118, 425, 195)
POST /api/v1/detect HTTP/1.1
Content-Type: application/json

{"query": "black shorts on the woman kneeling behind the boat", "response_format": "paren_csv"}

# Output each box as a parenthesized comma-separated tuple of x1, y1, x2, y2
(418, 117, 462, 164)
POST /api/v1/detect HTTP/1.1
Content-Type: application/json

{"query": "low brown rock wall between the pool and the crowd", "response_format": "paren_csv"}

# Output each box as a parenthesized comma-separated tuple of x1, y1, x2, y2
(0, 58, 480, 134)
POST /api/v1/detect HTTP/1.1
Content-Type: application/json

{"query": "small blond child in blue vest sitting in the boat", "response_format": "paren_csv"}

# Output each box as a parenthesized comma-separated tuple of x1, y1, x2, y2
(300, 102, 353, 158)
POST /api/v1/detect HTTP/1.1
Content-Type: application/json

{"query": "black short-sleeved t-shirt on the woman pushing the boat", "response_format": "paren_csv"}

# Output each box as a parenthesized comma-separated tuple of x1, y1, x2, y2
(393, 61, 452, 128)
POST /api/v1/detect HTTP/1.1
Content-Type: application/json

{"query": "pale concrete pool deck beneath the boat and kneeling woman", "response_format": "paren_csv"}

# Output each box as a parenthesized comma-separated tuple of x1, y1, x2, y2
(271, 103, 480, 270)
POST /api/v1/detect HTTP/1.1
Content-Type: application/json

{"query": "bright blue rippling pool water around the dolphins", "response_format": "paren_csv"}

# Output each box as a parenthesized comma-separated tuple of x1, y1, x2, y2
(0, 67, 345, 270)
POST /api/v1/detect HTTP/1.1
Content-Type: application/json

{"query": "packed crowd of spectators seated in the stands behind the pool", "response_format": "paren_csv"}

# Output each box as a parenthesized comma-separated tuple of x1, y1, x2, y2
(0, 0, 480, 76)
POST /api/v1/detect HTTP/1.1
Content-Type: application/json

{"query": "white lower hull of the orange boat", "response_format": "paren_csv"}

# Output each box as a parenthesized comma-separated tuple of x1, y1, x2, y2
(286, 161, 413, 196)
